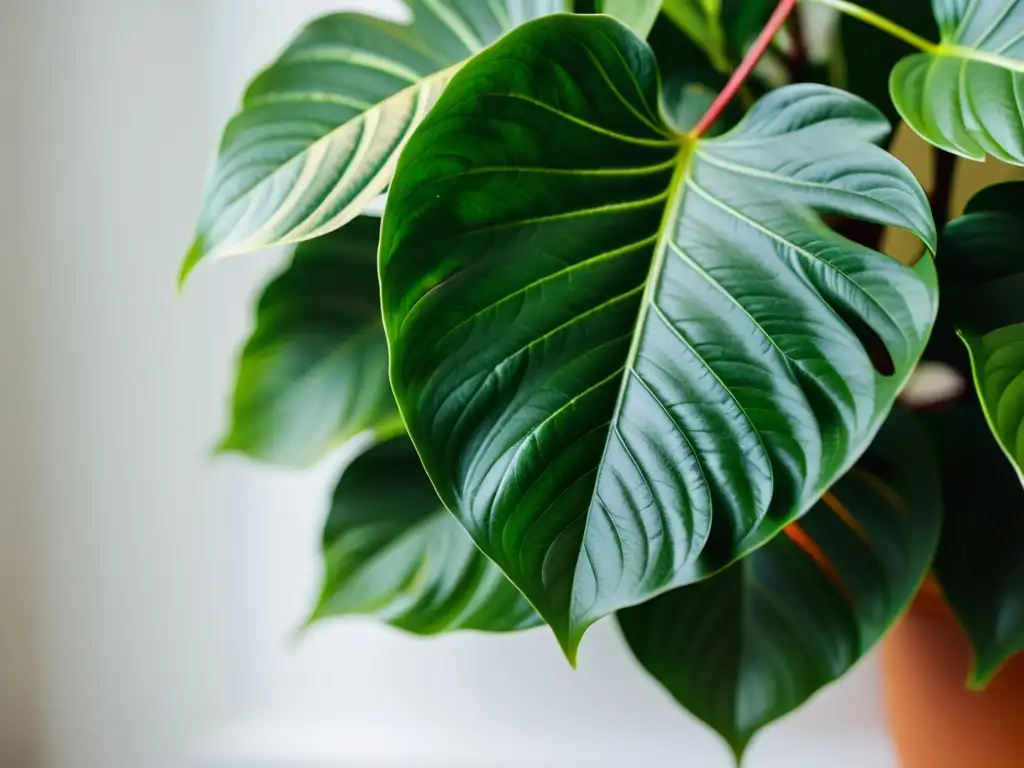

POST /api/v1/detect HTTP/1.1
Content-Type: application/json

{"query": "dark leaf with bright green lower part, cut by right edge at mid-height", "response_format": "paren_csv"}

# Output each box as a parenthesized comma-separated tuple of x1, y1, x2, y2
(941, 181, 1024, 481)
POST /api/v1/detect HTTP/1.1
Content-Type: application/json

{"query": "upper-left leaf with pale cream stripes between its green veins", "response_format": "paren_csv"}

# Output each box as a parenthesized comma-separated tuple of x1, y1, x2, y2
(182, 0, 564, 276)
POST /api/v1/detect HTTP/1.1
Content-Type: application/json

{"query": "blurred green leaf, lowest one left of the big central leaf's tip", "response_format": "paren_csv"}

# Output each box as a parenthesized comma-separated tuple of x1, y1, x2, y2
(313, 436, 541, 635)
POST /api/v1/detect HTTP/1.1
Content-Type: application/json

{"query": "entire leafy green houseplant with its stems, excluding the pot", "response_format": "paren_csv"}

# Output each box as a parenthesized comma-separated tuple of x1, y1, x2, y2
(182, 0, 1024, 759)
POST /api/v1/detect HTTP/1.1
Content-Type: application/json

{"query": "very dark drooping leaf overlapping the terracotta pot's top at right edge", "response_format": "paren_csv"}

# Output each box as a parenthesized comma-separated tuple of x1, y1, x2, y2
(925, 399, 1024, 688)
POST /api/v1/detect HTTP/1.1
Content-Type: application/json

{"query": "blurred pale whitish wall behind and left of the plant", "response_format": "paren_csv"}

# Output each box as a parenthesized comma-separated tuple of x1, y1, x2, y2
(0, 0, 999, 768)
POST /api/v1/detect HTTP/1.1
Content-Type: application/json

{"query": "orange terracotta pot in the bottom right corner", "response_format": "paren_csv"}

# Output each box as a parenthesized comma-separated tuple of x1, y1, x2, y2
(882, 584, 1024, 768)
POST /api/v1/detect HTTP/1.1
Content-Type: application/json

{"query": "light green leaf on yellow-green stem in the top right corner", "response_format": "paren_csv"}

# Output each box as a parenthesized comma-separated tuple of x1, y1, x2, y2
(891, 0, 1024, 165)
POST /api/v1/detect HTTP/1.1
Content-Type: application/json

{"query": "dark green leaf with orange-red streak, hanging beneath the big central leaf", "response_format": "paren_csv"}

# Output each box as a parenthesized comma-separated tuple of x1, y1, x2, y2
(618, 411, 942, 758)
